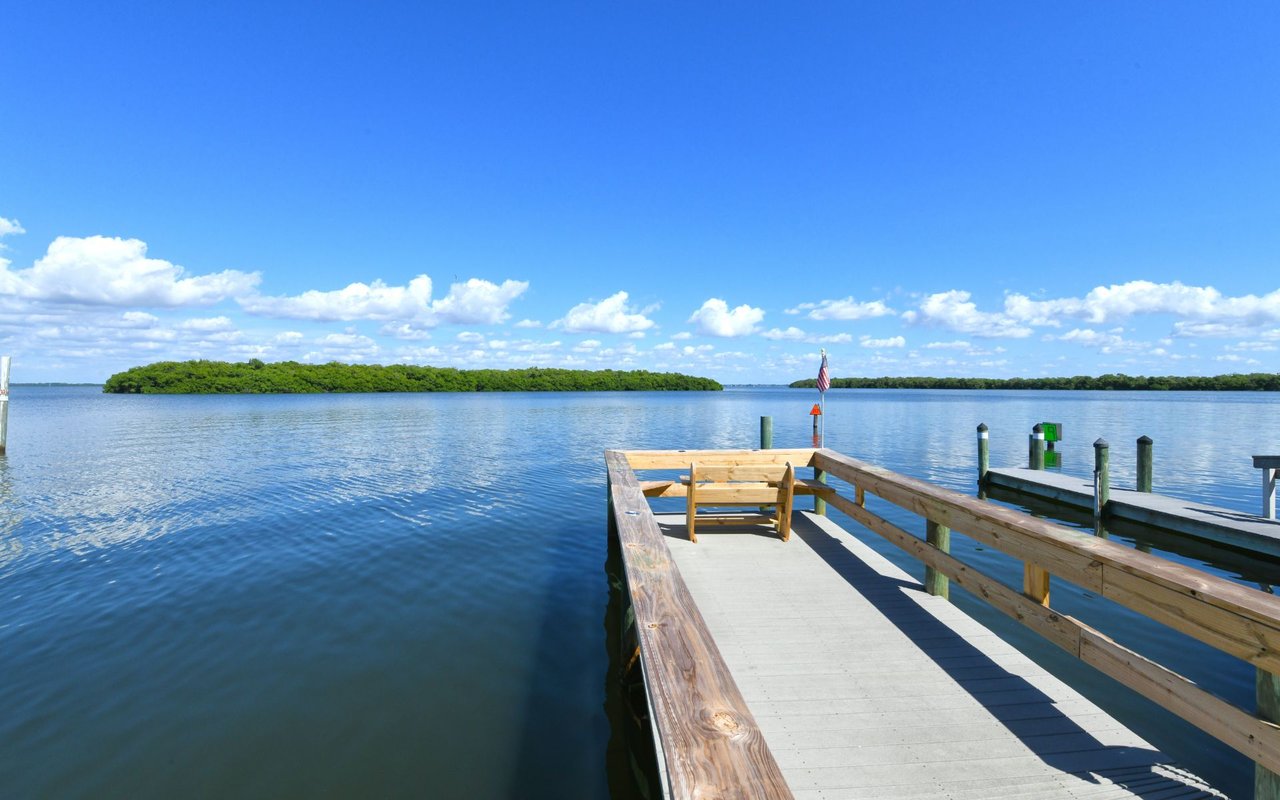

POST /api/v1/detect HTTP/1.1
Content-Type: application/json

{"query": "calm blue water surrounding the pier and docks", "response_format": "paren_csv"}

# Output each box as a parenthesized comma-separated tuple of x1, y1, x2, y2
(0, 387, 1280, 797)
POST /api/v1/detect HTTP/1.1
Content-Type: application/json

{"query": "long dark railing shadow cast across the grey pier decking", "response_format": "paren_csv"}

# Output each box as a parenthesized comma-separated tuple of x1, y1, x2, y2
(792, 515, 1215, 799)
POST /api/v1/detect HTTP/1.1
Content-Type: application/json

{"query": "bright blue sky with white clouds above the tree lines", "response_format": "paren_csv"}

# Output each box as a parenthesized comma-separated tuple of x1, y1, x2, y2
(0, 0, 1280, 383)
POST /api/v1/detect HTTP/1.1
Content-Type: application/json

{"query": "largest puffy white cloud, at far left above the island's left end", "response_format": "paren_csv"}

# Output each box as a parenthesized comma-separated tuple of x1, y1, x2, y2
(0, 236, 260, 307)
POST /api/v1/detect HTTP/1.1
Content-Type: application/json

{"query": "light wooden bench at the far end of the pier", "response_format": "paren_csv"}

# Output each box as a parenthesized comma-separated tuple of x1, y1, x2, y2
(680, 462, 796, 541)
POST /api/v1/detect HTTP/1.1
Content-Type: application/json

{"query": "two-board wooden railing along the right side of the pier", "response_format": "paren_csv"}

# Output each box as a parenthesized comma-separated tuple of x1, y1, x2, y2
(813, 449, 1280, 772)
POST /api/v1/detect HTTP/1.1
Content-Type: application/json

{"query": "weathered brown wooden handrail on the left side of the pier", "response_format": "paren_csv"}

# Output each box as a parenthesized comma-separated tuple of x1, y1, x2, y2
(604, 451, 788, 800)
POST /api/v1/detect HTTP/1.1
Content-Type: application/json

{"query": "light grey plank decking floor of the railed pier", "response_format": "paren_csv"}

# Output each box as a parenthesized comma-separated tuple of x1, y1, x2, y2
(655, 512, 1221, 800)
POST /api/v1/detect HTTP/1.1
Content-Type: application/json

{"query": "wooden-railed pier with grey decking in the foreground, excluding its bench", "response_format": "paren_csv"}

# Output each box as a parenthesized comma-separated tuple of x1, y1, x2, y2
(605, 449, 1280, 799)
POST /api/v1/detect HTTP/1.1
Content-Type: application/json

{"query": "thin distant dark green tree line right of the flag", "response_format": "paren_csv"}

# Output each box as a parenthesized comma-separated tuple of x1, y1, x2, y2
(791, 372, 1280, 392)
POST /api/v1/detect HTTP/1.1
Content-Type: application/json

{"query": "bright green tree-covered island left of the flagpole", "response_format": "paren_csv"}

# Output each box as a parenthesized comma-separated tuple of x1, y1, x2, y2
(102, 358, 723, 394)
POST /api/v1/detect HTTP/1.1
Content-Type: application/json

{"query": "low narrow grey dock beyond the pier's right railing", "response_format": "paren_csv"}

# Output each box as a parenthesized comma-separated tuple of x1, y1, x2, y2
(986, 467, 1280, 558)
